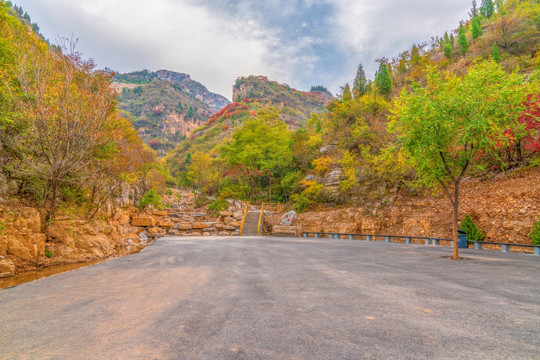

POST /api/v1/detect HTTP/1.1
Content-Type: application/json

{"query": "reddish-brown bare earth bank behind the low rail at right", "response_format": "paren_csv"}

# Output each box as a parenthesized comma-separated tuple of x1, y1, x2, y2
(268, 167, 540, 248)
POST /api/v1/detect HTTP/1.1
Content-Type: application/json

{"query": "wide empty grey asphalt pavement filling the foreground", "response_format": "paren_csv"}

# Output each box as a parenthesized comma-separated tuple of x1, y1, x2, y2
(0, 237, 540, 360)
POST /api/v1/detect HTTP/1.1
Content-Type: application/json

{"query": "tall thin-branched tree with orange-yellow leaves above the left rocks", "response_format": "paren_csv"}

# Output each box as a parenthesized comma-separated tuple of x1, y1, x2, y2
(17, 44, 116, 224)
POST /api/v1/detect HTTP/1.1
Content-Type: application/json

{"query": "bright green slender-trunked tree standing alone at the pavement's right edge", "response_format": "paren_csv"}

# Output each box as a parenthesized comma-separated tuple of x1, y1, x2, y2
(391, 61, 538, 259)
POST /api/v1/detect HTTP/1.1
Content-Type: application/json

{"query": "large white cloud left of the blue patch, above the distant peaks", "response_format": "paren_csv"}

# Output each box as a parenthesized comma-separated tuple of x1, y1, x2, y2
(20, 0, 289, 97)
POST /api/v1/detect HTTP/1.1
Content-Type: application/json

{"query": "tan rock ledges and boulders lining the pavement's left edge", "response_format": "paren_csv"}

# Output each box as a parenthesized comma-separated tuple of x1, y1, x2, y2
(0, 190, 249, 278)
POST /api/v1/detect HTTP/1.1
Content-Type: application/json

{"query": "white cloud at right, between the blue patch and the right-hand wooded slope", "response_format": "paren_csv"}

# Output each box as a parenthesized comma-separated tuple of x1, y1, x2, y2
(329, 0, 470, 88)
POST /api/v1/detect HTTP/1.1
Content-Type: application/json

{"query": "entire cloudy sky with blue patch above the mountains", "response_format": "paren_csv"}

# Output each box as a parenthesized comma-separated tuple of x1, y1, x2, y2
(13, 0, 471, 99)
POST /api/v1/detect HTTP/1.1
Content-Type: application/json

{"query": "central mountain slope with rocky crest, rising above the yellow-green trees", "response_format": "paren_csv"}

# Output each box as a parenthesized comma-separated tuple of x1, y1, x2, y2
(166, 76, 333, 175)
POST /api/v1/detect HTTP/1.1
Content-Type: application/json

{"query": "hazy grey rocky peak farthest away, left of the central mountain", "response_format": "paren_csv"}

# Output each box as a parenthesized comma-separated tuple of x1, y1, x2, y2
(114, 70, 230, 154)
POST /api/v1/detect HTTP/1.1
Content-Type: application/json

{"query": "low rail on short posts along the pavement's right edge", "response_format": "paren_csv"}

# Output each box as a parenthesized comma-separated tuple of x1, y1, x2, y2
(302, 232, 540, 255)
